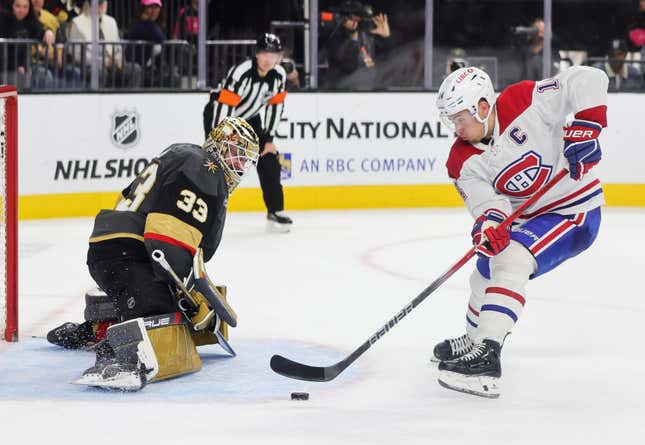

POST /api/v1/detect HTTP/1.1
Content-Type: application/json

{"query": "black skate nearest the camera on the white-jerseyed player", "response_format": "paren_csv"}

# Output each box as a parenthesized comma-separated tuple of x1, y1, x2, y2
(439, 340, 502, 398)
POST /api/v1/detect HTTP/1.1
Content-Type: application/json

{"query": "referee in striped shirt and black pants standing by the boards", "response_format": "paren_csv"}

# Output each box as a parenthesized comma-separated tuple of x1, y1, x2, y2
(204, 33, 292, 232)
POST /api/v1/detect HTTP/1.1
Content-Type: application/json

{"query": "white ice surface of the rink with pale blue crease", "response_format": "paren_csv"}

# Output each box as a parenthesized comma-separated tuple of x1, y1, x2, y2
(0, 209, 645, 445)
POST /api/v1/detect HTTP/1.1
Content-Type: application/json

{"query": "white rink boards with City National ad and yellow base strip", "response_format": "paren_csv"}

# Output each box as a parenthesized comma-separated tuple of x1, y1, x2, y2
(19, 93, 645, 217)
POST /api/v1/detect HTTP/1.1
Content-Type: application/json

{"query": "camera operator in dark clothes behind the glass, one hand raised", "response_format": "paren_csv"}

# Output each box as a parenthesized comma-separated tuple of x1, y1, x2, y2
(328, 1, 390, 89)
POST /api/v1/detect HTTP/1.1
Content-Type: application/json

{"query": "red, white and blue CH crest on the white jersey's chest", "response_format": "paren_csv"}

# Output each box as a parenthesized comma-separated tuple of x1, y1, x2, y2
(493, 151, 553, 197)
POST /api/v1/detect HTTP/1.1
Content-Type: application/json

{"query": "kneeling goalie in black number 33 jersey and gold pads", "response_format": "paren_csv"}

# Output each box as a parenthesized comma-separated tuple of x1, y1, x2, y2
(47, 117, 259, 391)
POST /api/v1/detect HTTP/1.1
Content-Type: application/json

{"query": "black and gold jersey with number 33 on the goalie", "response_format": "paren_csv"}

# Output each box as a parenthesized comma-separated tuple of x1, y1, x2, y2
(88, 144, 228, 276)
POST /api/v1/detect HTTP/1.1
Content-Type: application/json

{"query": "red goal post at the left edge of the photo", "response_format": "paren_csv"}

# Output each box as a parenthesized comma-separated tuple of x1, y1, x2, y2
(0, 85, 18, 341)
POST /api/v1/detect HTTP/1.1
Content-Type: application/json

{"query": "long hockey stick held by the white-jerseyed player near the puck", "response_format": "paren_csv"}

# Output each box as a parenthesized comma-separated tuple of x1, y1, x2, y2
(270, 169, 569, 382)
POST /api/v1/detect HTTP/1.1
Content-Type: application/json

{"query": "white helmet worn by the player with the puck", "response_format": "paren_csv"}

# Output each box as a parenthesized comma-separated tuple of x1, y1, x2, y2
(437, 66, 495, 134)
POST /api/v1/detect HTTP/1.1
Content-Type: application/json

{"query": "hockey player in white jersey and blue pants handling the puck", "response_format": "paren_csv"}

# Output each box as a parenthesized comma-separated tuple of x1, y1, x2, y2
(434, 67, 608, 397)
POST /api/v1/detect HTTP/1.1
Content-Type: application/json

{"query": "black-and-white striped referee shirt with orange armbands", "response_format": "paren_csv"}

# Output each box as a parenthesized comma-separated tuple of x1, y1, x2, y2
(211, 58, 287, 141)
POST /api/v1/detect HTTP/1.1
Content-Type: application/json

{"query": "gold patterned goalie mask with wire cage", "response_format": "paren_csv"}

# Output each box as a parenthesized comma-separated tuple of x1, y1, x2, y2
(203, 117, 260, 194)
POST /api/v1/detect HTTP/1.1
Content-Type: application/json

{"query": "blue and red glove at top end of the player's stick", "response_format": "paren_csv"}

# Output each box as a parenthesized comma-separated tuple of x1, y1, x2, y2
(564, 120, 602, 181)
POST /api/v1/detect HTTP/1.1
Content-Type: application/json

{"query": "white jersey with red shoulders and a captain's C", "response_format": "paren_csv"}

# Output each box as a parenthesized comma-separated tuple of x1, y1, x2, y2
(446, 67, 608, 221)
